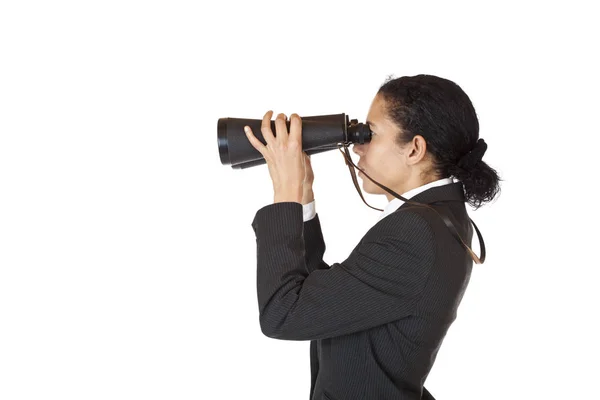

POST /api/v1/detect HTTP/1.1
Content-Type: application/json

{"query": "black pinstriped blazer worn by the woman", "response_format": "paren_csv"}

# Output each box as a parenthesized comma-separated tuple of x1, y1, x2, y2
(252, 182, 473, 400)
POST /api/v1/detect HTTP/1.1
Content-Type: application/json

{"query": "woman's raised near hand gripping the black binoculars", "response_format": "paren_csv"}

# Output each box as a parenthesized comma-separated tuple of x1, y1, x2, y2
(244, 111, 304, 203)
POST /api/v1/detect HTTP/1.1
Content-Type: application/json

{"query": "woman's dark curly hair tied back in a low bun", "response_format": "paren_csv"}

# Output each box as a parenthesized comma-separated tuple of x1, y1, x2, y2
(378, 75, 500, 209)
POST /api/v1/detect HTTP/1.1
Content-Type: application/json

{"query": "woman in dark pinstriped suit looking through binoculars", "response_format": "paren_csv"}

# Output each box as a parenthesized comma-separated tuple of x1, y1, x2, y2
(246, 75, 499, 400)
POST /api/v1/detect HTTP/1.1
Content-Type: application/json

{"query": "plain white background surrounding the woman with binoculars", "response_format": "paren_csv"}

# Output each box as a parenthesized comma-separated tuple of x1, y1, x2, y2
(0, 0, 600, 400)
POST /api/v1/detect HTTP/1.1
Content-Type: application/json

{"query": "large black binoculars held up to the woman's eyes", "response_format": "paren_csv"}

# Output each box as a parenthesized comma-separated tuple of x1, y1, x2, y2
(217, 114, 371, 169)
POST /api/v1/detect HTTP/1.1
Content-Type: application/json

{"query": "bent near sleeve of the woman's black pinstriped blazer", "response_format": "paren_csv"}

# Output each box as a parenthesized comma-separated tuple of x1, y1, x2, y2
(252, 202, 435, 340)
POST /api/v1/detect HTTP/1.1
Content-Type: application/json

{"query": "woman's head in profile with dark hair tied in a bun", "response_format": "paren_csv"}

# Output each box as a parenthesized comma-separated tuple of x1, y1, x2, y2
(353, 75, 500, 208)
